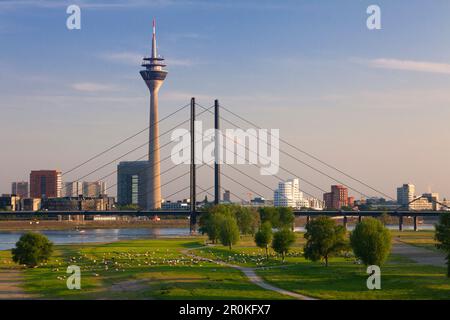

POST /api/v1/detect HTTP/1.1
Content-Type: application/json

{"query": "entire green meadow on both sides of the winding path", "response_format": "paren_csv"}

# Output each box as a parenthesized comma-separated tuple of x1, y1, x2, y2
(0, 232, 450, 299)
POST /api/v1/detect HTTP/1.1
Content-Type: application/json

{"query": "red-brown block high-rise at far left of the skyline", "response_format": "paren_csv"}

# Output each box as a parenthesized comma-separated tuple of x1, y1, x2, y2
(30, 170, 62, 198)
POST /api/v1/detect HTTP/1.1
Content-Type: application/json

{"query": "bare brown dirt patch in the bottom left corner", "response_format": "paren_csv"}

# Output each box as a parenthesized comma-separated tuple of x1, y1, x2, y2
(0, 269, 33, 300)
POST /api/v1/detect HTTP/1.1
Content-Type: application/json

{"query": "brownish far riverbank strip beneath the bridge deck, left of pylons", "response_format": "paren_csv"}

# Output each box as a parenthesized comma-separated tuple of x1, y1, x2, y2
(0, 219, 189, 231)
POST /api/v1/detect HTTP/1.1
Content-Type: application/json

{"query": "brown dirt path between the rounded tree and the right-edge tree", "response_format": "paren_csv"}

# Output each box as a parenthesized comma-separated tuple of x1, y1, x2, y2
(392, 239, 446, 267)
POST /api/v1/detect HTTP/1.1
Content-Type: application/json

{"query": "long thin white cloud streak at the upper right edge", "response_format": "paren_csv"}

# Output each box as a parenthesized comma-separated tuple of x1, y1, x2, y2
(369, 58, 450, 74)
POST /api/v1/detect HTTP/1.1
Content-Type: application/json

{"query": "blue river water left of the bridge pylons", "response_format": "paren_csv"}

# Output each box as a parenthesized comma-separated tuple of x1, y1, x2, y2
(0, 228, 189, 250)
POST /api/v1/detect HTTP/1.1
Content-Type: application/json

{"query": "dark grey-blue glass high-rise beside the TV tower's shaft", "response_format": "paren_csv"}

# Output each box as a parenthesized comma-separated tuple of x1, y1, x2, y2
(117, 161, 149, 210)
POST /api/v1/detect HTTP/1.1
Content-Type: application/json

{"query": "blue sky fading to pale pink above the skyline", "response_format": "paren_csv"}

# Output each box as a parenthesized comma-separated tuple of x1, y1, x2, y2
(0, 0, 450, 200)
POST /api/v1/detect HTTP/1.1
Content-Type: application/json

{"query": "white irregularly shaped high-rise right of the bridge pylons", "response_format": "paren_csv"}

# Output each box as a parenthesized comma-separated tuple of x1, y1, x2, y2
(273, 178, 309, 208)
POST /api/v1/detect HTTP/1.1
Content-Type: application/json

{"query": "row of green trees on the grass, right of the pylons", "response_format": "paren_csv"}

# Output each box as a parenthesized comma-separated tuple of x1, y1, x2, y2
(200, 205, 391, 266)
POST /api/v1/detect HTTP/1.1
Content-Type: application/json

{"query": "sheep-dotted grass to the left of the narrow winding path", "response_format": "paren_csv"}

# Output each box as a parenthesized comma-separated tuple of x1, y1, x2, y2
(0, 238, 286, 299)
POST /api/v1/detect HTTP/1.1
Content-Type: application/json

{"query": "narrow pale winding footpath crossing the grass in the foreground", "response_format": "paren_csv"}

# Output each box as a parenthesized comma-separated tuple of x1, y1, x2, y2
(181, 249, 316, 300)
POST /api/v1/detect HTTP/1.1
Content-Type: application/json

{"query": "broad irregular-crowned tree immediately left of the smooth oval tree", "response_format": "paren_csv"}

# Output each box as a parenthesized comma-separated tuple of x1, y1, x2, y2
(304, 216, 347, 266)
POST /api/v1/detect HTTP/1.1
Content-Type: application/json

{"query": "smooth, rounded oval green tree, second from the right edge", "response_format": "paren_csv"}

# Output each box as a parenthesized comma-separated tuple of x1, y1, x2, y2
(350, 218, 391, 266)
